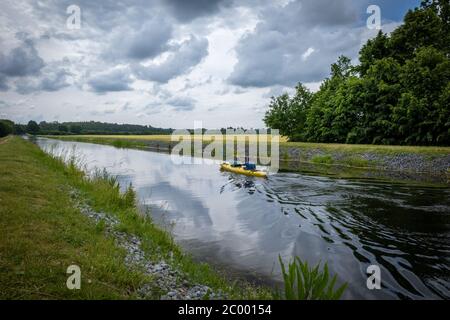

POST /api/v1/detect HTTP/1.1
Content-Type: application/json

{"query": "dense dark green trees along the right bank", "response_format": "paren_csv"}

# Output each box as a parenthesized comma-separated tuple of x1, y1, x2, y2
(264, 0, 450, 145)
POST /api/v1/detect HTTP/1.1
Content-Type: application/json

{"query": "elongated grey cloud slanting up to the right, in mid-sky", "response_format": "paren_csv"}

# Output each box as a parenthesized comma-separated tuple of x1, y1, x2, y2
(134, 36, 208, 83)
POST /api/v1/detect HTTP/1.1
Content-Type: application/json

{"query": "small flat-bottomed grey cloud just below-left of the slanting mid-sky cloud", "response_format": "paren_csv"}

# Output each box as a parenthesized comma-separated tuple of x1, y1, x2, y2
(88, 69, 132, 93)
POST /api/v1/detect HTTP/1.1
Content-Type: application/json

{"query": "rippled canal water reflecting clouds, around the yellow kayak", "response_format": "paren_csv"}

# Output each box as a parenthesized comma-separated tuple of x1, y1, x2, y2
(37, 139, 450, 299)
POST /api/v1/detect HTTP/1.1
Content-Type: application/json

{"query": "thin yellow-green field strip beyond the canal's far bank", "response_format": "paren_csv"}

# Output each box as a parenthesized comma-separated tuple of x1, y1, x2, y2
(47, 135, 450, 155)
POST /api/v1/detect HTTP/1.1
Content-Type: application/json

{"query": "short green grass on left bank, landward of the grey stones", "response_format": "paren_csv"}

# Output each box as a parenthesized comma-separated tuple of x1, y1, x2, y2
(0, 138, 149, 299)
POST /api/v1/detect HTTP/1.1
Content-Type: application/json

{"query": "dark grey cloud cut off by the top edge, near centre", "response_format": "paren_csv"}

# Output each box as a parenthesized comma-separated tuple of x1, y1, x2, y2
(164, 0, 232, 22)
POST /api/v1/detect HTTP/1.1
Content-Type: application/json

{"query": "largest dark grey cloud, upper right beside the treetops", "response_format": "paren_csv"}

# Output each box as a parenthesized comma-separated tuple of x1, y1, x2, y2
(229, 0, 360, 87)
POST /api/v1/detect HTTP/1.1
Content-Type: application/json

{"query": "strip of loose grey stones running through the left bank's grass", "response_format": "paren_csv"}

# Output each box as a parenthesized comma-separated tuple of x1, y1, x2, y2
(70, 189, 226, 300)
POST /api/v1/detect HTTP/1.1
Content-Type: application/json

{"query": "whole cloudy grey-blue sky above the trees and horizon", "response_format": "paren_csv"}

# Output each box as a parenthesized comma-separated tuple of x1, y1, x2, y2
(0, 0, 420, 128)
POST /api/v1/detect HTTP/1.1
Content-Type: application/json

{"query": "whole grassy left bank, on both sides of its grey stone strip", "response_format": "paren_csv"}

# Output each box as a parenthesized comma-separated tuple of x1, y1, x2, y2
(0, 137, 271, 299)
